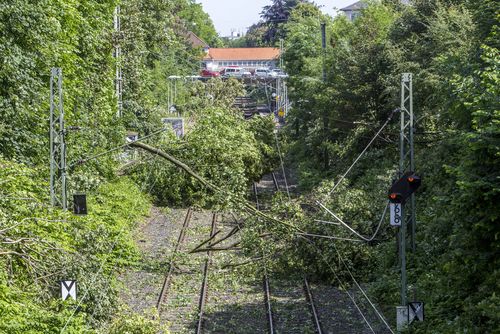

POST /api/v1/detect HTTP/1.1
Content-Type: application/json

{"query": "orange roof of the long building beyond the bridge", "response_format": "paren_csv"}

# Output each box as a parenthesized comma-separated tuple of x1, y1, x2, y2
(204, 48, 280, 60)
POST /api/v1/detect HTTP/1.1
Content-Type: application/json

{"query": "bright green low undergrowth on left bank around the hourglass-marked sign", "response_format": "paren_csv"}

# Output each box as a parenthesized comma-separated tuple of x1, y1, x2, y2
(0, 160, 150, 333)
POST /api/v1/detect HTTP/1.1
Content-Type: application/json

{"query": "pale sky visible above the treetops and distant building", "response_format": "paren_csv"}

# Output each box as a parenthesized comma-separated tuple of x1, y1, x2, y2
(196, 0, 357, 36)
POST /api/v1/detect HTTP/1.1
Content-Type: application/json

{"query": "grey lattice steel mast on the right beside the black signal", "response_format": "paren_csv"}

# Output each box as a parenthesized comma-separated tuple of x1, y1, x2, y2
(398, 73, 415, 330)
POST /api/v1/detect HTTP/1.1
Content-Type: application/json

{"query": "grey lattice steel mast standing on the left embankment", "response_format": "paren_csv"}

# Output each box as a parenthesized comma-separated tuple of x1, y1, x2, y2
(50, 68, 67, 210)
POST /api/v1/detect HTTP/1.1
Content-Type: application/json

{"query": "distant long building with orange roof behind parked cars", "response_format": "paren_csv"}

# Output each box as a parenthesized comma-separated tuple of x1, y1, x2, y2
(203, 48, 280, 70)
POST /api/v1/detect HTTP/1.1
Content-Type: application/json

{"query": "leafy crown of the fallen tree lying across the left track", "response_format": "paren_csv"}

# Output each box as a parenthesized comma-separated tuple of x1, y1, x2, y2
(135, 79, 276, 209)
